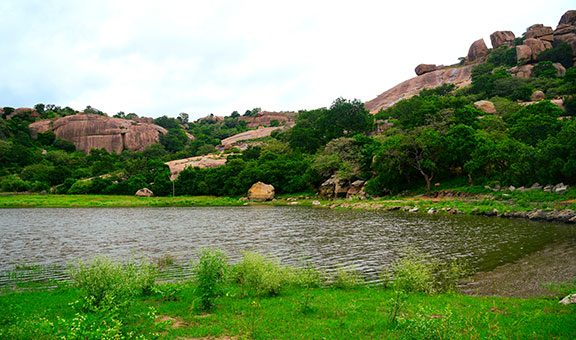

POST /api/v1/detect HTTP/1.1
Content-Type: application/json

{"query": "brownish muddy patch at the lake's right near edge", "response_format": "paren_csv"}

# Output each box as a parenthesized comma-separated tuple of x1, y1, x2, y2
(461, 243, 576, 297)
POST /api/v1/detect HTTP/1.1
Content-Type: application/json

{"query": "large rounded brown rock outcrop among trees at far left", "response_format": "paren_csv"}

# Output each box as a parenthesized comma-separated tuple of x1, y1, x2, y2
(29, 114, 167, 153)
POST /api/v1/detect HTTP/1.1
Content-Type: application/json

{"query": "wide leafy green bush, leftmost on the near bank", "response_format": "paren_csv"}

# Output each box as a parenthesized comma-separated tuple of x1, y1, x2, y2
(69, 257, 157, 310)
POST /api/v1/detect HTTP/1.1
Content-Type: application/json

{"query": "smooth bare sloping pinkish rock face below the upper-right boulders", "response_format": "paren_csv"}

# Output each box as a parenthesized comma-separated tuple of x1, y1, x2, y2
(364, 65, 473, 113)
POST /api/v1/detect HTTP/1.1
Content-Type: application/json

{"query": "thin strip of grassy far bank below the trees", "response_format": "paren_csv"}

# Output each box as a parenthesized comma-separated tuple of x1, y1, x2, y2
(0, 187, 576, 222)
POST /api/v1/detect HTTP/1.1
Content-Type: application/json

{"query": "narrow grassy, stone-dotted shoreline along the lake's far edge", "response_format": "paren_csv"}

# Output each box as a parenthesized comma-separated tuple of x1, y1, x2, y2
(0, 192, 576, 224)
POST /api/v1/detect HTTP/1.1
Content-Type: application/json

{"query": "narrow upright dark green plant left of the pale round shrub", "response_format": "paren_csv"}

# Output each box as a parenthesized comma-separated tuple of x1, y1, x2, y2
(193, 249, 228, 312)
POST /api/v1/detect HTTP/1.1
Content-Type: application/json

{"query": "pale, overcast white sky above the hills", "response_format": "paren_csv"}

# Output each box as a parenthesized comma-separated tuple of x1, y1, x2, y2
(0, 0, 576, 119)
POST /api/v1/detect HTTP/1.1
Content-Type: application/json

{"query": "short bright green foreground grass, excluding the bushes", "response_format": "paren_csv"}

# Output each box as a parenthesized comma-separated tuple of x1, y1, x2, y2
(0, 283, 576, 339)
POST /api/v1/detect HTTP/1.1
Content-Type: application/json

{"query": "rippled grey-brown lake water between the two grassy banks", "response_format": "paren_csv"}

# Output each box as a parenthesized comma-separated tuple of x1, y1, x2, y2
(0, 207, 576, 285)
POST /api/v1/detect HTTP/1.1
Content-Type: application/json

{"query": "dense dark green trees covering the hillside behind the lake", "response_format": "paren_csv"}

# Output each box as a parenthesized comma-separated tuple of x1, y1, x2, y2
(0, 44, 576, 196)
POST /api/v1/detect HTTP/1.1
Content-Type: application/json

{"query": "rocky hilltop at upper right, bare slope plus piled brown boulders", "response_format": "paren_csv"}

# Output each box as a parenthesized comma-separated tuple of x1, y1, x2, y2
(365, 10, 576, 113)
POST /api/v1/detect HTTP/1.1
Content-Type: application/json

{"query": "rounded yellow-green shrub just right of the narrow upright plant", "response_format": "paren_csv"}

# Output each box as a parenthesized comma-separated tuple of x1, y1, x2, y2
(234, 252, 288, 296)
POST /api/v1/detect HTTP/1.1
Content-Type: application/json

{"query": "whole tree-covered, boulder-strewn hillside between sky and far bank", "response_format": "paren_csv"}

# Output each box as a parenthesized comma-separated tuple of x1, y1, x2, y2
(0, 11, 576, 198)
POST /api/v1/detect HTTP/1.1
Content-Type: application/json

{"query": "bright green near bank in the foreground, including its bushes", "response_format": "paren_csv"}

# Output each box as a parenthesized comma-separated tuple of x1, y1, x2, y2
(0, 252, 576, 339)
